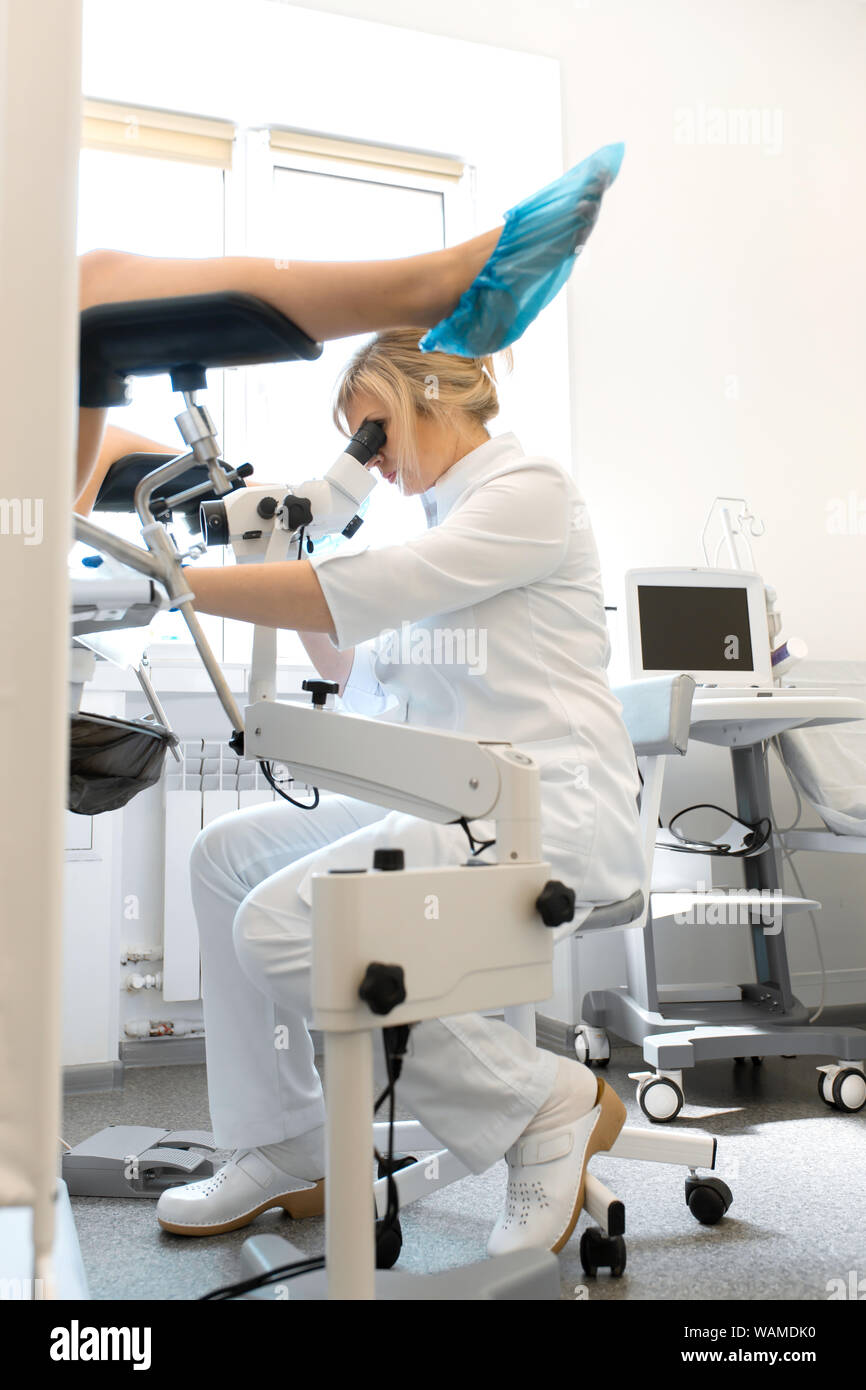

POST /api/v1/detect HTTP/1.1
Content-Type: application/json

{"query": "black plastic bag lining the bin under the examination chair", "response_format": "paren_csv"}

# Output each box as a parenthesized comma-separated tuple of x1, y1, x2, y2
(67, 713, 178, 816)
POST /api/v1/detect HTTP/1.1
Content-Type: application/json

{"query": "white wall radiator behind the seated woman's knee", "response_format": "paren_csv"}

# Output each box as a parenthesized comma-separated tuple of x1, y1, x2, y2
(163, 738, 287, 1001)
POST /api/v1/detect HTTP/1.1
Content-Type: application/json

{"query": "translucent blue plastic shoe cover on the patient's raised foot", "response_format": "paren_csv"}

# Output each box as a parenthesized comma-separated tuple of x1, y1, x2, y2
(418, 145, 626, 357)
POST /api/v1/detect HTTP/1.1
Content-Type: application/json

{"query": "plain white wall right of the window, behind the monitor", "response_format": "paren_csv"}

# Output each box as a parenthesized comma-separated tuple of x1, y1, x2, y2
(264, 0, 866, 1001)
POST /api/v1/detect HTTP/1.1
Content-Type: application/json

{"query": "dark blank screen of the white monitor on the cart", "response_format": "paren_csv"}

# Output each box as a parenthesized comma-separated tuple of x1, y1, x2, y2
(638, 584, 753, 671)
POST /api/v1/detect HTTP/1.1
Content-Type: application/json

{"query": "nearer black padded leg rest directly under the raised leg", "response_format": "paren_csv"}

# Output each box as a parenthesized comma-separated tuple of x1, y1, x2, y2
(79, 291, 321, 409)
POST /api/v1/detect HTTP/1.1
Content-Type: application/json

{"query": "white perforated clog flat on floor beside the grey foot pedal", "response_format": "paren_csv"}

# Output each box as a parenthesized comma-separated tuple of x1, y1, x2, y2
(156, 1148, 325, 1236)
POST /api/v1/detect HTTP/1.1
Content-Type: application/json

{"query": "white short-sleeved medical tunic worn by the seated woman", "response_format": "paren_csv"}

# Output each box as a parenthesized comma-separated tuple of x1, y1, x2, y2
(313, 434, 642, 904)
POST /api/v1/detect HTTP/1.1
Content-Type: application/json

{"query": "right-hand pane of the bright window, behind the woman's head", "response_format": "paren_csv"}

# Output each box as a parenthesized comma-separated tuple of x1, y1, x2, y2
(225, 131, 467, 664)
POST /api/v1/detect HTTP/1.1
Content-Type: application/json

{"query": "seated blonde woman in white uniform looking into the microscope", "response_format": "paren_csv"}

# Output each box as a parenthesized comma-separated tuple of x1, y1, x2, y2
(157, 328, 641, 1254)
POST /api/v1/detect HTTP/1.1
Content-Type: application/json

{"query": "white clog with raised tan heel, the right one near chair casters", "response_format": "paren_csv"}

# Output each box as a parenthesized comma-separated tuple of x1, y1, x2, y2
(487, 1081, 626, 1255)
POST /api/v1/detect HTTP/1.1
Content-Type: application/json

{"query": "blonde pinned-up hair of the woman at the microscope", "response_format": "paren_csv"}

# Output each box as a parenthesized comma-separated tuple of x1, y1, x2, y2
(334, 328, 513, 480)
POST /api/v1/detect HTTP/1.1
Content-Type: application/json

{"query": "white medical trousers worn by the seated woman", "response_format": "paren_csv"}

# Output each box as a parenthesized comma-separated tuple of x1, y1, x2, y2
(190, 796, 557, 1173)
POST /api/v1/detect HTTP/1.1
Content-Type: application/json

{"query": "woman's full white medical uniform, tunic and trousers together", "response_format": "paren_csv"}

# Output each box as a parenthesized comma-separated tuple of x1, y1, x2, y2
(192, 434, 641, 1172)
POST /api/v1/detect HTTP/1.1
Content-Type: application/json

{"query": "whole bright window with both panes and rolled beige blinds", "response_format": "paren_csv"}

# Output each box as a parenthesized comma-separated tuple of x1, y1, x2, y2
(79, 103, 471, 666)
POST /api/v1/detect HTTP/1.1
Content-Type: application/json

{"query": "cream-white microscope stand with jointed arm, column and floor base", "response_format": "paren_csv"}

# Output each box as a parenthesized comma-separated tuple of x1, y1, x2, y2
(245, 701, 562, 1298)
